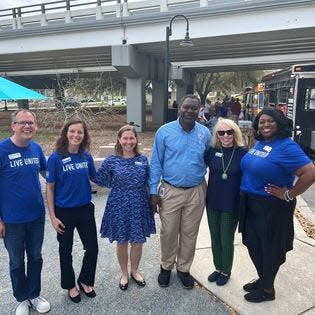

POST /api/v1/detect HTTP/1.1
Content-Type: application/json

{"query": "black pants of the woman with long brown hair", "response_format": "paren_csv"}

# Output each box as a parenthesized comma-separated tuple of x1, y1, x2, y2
(55, 203, 98, 290)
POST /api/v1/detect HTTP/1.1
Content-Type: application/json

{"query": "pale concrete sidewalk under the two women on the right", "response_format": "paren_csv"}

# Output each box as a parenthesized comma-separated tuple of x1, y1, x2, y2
(191, 198, 315, 315)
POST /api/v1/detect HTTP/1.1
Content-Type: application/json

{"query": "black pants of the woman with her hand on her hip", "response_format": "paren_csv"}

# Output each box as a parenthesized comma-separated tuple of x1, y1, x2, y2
(241, 194, 296, 289)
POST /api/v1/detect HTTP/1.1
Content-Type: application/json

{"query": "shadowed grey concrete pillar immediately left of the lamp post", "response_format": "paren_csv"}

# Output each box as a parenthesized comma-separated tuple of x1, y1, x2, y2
(152, 80, 165, 126)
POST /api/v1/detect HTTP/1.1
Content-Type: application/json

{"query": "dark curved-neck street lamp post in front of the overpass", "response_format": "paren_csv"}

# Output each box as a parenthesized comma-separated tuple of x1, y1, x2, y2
(163, 14, 193, 123)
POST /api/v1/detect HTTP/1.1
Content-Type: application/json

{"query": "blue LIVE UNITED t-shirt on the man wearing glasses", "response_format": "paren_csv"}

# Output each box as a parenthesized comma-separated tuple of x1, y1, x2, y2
(0, 138, 46, 223)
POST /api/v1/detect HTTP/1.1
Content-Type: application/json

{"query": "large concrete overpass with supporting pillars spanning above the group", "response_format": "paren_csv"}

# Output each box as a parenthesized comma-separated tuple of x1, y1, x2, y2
(0, 0, 315, 130)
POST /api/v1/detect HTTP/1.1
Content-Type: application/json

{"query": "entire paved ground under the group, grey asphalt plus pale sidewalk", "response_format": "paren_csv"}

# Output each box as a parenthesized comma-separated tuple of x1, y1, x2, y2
(0, 189, 315, 315)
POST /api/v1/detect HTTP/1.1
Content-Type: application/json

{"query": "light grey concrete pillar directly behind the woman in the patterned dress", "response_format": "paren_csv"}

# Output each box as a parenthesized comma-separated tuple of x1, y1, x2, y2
(127, 78, 145, 132)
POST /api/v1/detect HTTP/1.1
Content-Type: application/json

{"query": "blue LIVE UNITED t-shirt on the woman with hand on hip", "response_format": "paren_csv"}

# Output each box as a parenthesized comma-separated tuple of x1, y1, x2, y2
(241, 138, 310, 196)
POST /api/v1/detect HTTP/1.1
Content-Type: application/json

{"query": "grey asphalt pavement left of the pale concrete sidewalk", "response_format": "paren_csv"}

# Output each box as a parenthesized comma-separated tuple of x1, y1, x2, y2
(0, 190, 230, 315)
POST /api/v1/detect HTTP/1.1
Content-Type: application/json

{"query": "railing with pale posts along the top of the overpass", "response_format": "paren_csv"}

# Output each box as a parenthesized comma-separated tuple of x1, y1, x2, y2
(0, 0, 314, 32)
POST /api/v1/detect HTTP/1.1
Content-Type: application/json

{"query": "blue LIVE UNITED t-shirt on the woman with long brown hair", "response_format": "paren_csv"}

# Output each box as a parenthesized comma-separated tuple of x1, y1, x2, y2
(46, 151, 96, 208)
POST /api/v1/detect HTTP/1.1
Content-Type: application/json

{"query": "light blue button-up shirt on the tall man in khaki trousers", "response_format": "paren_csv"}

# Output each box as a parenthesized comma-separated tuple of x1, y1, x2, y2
(149, 119, 211, 195)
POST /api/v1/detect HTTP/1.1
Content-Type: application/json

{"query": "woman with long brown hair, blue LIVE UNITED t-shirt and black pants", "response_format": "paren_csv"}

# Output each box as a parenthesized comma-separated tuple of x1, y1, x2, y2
(46, 119, 98, 303)
